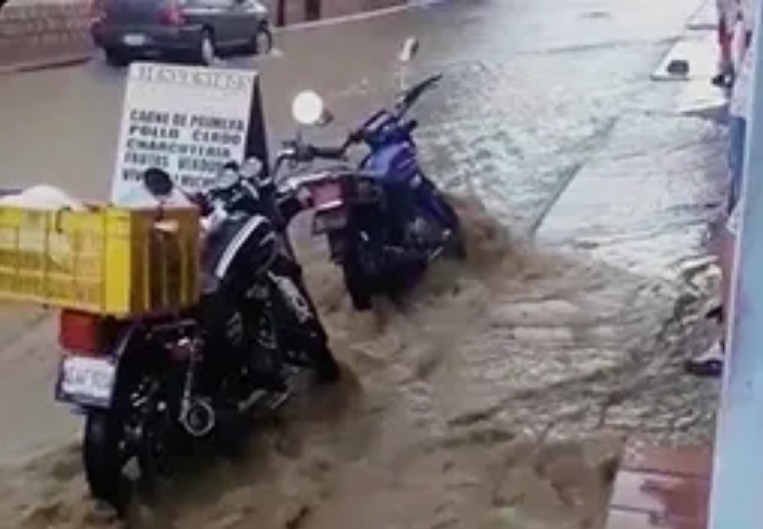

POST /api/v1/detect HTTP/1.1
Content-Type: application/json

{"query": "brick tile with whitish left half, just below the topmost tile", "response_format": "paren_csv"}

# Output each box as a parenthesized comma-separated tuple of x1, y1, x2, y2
(610, 470, 710, 518)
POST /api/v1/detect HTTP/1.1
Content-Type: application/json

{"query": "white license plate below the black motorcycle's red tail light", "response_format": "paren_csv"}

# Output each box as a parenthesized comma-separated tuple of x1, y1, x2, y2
(58, 356, 116, 407)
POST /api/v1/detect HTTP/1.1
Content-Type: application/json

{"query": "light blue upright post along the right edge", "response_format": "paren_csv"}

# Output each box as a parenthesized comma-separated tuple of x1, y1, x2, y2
(708, 0, 763, 529)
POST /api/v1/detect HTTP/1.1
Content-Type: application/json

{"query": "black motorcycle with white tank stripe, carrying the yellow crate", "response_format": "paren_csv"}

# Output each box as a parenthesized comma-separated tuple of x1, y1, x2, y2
(56, 159, 340, 511)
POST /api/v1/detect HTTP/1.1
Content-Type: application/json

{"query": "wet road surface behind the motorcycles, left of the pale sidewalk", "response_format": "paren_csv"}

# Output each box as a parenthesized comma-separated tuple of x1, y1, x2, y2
(0, 0, 716, 231)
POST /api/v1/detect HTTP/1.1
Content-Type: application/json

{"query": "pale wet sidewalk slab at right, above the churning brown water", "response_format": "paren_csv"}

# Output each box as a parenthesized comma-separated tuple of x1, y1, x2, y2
(538, 8, 725, 280)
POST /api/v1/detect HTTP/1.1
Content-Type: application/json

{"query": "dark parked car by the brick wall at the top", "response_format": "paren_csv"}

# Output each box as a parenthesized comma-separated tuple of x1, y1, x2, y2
(91, 0, 273, 66)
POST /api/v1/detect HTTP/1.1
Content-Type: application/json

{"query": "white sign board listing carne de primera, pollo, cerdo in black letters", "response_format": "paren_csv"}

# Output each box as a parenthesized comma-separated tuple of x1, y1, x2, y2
(111, 62, 257, 205)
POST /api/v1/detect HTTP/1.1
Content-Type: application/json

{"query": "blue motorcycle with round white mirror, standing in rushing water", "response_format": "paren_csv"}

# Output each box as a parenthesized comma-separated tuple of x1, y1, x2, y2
(276, 39, 466, 311)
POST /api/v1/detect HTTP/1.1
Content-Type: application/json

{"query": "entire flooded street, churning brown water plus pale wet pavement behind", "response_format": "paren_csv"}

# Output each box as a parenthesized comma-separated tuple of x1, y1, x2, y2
(0, 0, 721, 529)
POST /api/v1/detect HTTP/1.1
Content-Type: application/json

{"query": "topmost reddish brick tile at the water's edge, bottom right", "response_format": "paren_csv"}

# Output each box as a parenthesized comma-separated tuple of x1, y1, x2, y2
(621, 443, 713, 478)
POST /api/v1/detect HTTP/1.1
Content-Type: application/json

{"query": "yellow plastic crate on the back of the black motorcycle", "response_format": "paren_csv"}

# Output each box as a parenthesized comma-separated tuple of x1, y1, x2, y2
(0, 207, 200, 317)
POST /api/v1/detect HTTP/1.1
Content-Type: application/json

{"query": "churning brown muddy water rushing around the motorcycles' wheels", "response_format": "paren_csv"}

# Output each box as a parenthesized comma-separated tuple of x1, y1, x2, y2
(0, 194, 724, 529)
